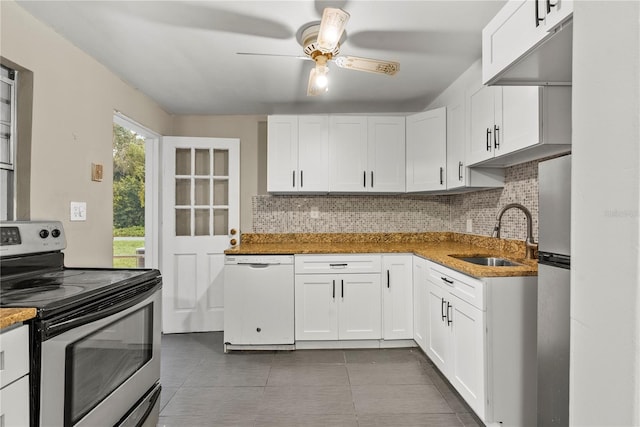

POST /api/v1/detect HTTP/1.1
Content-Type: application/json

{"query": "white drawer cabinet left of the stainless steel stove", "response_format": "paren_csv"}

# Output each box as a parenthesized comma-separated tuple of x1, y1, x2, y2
(0, 325, 30, 426)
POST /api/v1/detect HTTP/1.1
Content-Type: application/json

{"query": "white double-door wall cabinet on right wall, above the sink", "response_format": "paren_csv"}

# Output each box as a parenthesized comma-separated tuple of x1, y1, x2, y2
(466, 86, 571, 167)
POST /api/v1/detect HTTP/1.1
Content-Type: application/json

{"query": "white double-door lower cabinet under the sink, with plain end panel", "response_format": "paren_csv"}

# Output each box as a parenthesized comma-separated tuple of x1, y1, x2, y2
(426, 261, 537, 426)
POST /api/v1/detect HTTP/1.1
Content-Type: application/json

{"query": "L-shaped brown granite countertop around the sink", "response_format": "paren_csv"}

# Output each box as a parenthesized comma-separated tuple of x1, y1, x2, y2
(225, 232, 538, 277)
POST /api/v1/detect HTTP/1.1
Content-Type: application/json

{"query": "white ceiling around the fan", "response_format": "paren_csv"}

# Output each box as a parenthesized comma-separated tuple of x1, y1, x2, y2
(19, 0, 505, 115)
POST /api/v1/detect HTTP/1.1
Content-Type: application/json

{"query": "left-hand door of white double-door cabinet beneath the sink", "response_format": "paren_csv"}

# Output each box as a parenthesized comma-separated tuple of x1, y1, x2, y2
(427, 282, 451, 377)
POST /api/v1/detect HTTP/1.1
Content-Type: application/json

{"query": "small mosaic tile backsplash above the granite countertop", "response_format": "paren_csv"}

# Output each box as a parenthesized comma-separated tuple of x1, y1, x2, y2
(252, 161, 556, 241)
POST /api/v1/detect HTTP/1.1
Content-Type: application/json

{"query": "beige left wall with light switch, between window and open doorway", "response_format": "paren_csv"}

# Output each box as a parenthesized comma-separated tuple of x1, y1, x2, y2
(0, 1, 171, 266)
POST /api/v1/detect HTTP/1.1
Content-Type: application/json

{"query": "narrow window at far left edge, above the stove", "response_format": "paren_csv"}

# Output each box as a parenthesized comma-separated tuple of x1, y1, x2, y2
(0, 66, 17, 220)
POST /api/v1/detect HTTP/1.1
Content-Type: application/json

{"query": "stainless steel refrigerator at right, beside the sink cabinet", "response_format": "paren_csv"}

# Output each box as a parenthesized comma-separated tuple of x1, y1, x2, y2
(538, 155, 571, 426)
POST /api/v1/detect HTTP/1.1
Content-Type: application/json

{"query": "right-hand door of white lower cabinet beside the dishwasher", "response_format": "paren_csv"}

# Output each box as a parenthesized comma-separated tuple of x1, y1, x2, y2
(335, 274, 382, 340)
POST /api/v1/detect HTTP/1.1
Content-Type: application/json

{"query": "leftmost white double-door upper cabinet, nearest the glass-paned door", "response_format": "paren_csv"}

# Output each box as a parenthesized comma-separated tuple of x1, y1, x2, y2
(267, 115, 329, 193)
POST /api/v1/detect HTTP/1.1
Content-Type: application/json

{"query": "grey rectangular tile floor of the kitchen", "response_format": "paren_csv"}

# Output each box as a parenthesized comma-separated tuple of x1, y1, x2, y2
(158, 332, 482, 427)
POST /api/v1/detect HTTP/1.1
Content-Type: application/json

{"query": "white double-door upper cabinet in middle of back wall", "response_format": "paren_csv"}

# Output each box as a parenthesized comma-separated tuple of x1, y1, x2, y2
(329, 116, 405, 193)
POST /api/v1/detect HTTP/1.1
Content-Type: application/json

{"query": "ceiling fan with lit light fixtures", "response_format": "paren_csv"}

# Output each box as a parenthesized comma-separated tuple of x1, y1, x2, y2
(238, 7, 400, 96)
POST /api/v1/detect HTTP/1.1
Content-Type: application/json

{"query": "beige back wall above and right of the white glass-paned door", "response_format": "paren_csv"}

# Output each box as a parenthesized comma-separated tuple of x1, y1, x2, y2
(173, 116, 267, 233)
